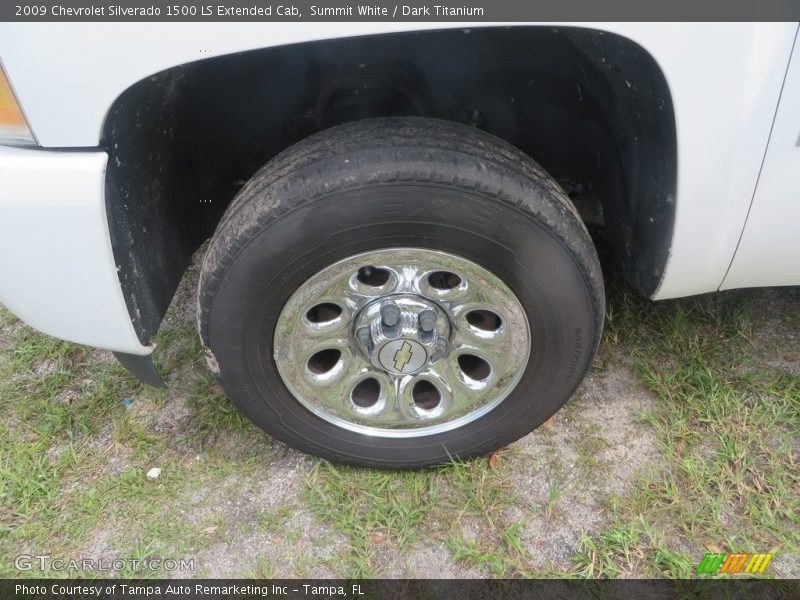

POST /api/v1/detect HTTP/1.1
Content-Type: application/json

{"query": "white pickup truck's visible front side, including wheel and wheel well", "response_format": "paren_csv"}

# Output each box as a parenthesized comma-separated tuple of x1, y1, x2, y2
(0, 23, 800, 468)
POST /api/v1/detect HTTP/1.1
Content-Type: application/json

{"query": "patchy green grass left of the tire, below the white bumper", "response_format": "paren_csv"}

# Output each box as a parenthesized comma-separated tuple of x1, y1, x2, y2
(0, 309, 256, 577)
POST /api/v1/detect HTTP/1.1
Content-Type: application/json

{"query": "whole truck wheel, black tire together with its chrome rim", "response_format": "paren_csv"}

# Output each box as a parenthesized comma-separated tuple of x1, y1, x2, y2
(198, 118, 604, 468)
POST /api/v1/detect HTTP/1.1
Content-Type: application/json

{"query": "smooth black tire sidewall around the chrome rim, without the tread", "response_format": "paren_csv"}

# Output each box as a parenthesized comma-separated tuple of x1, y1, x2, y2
(208, 181, 602, 467)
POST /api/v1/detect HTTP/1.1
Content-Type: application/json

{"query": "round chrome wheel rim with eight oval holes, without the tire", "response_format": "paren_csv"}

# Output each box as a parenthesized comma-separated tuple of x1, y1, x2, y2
(274, 248, 531, 438)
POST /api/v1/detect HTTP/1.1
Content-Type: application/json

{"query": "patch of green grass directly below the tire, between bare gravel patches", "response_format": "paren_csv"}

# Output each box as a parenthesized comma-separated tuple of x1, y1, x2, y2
(305, 458, 548, 577)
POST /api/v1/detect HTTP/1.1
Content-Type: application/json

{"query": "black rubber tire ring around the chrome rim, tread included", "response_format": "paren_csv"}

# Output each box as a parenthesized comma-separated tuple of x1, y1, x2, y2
(198, 118, 605, 468)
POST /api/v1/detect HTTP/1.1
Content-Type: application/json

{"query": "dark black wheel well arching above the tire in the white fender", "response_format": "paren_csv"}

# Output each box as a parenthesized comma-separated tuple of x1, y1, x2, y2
(102, 27, 677, 343)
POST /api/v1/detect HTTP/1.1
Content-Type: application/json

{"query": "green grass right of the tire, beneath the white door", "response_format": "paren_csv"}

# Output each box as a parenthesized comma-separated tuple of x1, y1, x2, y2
(574, 290, 800, 577)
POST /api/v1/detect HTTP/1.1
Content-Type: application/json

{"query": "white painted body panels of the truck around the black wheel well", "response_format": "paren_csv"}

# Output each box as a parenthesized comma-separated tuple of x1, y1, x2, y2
(0, 23, 800, 355)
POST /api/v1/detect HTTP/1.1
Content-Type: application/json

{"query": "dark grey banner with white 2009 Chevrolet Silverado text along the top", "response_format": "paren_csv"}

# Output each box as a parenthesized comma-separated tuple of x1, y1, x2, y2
(0, 0, 800, 23)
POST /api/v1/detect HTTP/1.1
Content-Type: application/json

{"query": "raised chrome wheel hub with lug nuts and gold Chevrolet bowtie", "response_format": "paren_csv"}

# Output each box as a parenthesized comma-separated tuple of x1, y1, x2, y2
(353, 294, 450, 376)
